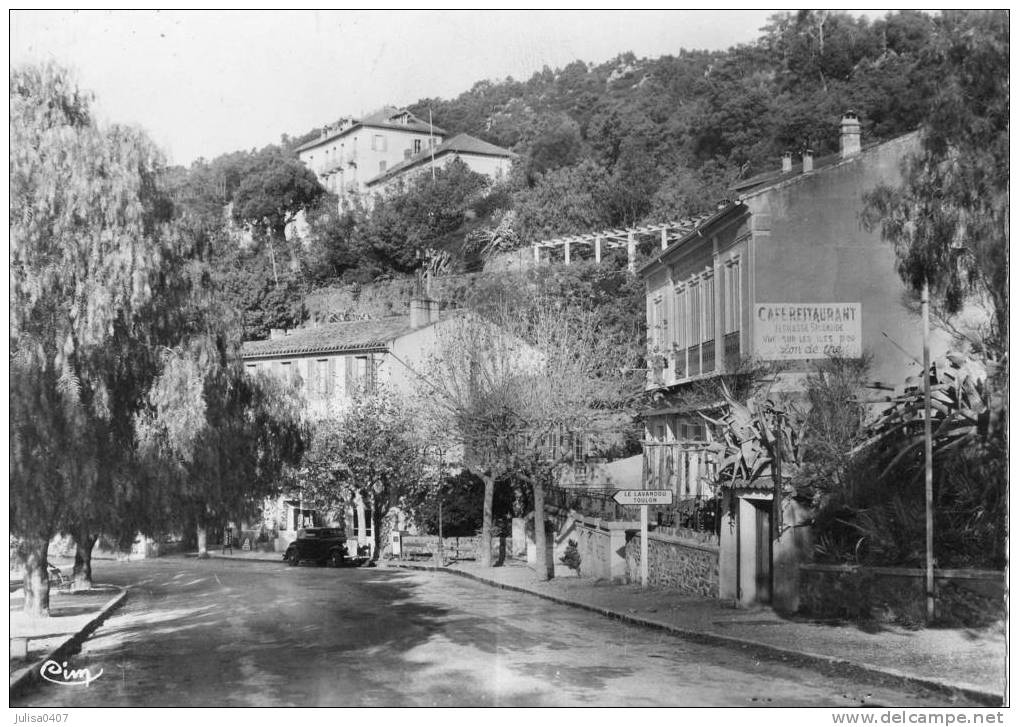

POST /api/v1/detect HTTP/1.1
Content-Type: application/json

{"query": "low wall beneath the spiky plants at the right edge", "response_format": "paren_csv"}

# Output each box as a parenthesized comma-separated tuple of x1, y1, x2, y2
(799, 564, 1005, 626)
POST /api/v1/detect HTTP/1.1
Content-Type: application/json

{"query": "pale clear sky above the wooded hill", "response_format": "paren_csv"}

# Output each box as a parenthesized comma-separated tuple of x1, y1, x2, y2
(10, 10, 876, 164)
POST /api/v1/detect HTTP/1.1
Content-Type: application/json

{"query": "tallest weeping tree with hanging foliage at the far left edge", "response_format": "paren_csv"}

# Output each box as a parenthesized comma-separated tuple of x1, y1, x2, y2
(9, 65, 168, 615)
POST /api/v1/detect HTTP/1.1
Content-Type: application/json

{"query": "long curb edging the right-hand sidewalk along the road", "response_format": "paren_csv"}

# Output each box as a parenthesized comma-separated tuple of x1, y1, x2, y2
(395, 564, 1004, 707)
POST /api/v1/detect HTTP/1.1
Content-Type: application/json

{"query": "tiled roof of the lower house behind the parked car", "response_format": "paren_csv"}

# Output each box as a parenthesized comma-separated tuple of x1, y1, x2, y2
(240, 315, 413, 359)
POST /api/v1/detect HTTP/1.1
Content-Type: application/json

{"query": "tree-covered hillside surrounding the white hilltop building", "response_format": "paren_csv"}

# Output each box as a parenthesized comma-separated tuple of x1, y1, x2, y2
(169, 10, 1007, 337)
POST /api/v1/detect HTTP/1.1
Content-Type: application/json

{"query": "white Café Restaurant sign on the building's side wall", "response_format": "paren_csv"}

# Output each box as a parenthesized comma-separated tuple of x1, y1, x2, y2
(753, 303, 863, 361)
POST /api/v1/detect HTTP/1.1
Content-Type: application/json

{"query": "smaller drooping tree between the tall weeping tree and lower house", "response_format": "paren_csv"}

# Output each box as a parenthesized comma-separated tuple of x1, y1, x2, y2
(137, 354, 309, 554)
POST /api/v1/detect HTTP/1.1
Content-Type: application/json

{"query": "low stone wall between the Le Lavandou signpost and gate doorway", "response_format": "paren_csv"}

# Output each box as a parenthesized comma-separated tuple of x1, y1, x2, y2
(627, 532, 718, 599)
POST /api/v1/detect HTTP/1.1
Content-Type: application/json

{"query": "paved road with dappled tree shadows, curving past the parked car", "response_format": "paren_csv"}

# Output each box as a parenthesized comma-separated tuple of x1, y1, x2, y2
(16, 559, 944, 708)
